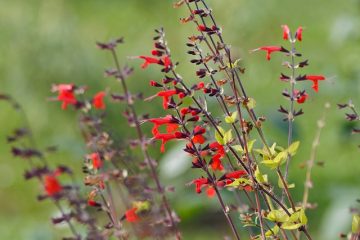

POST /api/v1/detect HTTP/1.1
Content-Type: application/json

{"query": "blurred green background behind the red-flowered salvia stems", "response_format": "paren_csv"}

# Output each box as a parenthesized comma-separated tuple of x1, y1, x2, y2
(0, 0, 360, 240)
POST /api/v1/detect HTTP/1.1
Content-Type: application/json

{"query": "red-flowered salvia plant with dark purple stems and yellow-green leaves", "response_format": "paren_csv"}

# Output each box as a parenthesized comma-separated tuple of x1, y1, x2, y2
(0, 0, 360, 240)
